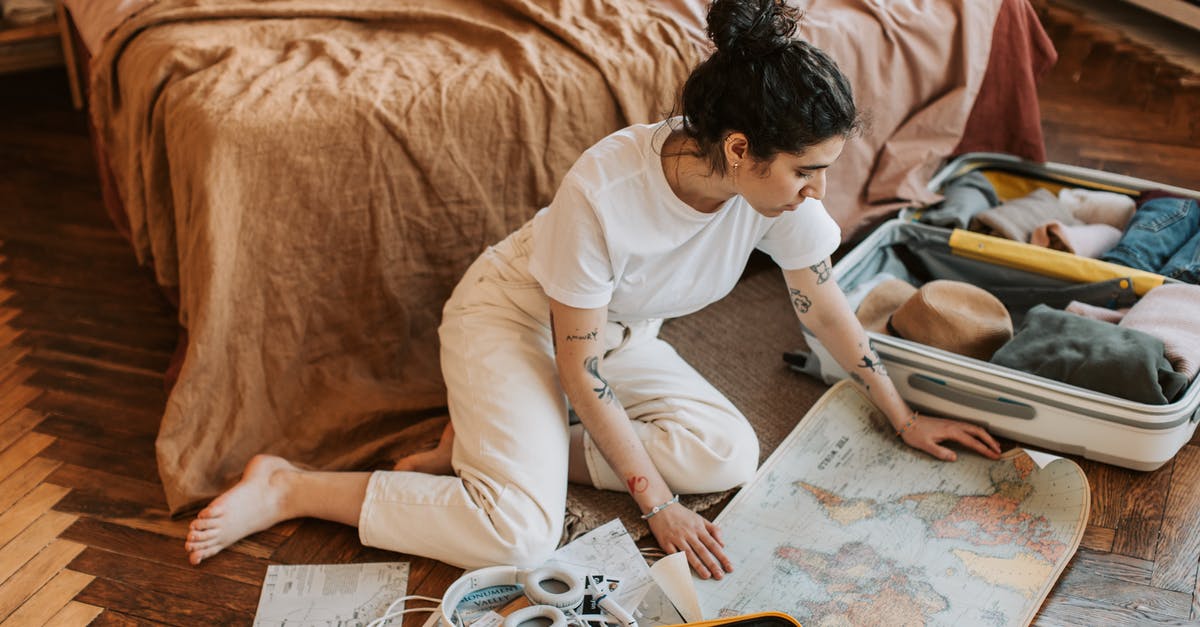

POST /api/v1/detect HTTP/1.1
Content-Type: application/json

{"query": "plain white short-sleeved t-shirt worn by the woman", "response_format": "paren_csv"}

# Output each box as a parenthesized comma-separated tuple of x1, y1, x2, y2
(529, 121, 841, 322)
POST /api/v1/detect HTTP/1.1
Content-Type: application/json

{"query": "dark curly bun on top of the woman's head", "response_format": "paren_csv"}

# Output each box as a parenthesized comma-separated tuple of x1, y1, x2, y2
(708, 0, 799, 59)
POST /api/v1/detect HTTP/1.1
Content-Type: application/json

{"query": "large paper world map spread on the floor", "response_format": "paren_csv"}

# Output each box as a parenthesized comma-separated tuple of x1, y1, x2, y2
(697, 383, 1090, 626)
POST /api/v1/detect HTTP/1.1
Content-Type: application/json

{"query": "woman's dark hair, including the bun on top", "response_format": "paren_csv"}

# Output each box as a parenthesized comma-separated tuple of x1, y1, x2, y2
(682, 0, 862, 174)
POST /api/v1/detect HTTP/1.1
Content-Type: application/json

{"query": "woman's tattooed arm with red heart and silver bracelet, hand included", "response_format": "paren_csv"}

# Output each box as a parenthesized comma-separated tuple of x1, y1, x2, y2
(550, 299, 732, 579)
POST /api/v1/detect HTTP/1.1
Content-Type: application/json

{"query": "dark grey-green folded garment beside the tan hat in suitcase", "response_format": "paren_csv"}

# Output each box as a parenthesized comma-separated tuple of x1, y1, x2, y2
(991, 305, 1188, 405)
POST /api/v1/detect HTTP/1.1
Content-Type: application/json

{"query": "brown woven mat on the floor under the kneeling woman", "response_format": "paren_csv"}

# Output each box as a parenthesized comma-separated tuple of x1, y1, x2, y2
(563, 259, 827, 543)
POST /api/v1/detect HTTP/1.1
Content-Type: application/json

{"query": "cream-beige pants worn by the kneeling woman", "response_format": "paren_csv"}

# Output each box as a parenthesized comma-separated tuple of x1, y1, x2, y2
(359, 225, 758, 568)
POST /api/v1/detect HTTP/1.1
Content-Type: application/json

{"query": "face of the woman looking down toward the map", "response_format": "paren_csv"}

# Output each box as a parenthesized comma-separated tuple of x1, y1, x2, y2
(734, 137, 846, 217)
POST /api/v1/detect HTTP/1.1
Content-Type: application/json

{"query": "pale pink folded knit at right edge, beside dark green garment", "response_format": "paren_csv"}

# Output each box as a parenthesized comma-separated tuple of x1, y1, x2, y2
(1121, 283, 1200, 381)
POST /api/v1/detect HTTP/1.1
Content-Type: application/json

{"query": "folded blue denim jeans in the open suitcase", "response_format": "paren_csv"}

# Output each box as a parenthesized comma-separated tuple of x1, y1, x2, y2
(1100, 197, 1200, 283)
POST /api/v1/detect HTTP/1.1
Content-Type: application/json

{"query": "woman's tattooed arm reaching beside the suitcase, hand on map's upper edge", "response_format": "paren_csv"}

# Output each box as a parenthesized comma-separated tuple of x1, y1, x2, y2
(784, 259, 1000, 461)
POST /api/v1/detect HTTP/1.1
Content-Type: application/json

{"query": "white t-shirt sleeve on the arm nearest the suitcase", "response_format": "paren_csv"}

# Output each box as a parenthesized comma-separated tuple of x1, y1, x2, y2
(757, 198, 841, 270)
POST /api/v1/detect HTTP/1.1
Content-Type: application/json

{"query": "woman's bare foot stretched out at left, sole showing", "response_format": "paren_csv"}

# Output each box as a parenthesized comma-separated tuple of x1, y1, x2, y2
(184, 455, 301, 565)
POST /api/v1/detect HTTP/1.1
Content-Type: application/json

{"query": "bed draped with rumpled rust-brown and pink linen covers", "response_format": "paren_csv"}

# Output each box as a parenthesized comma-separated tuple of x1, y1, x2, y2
(66, 0, 1054, 514)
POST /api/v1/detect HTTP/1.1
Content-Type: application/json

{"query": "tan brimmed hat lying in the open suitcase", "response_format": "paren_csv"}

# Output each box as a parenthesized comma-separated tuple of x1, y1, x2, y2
(856, 279, 1013, 362)
